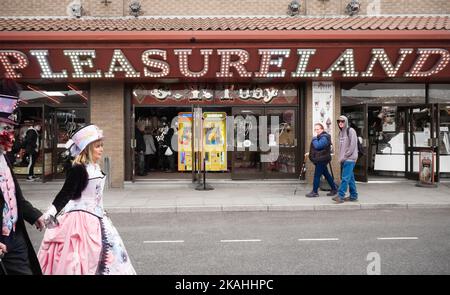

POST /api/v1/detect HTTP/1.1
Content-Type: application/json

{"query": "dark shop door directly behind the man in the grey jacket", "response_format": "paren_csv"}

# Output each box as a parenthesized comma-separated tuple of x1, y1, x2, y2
(342, 104, 369, 182)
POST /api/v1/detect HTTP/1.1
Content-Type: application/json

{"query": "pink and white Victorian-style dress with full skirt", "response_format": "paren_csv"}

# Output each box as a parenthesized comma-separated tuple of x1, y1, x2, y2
(38, 164, 136, 275)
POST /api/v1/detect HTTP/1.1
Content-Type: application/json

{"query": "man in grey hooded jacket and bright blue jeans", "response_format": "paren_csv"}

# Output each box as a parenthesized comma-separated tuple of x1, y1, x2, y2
(332, 116, 358, 204)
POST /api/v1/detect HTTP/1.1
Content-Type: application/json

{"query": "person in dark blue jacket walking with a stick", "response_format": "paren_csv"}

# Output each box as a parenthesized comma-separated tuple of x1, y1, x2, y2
(306, 123, 337, 198)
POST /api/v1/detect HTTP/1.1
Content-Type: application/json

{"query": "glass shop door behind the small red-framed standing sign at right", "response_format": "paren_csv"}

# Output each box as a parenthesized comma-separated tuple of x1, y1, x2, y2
(404, 105, 439, 181)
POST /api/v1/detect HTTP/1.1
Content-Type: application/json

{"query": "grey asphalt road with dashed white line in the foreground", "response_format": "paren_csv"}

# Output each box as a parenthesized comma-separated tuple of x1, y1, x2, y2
(29, 209, 450, 275)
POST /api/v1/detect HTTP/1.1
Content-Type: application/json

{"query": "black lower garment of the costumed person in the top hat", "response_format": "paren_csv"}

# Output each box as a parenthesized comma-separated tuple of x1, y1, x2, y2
(0, 232, 33, 275)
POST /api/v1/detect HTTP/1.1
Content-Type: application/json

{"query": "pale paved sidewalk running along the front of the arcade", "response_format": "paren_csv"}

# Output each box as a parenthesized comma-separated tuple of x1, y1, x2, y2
(20, 179, 450, 213)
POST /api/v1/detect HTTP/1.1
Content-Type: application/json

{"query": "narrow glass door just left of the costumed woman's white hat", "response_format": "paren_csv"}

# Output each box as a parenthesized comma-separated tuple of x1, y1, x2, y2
(40, 105, 57, 182)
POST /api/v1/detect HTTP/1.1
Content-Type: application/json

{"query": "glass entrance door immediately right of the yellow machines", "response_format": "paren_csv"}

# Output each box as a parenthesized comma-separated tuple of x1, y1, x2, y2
(231, 107, 264, 179)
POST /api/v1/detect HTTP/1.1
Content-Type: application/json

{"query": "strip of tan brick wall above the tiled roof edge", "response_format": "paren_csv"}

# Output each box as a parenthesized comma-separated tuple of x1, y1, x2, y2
(0, 0, 450, 17)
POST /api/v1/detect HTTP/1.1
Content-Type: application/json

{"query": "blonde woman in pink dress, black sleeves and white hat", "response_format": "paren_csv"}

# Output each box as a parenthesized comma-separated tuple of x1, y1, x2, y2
(38, 125, 136, 275)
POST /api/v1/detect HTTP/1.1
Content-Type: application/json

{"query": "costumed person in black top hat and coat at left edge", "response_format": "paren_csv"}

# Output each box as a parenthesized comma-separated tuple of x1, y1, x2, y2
(0, 80, 45, 275)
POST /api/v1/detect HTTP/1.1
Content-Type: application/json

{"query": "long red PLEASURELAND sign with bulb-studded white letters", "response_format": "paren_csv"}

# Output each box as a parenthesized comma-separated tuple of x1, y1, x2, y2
(0, 44, 450, 82)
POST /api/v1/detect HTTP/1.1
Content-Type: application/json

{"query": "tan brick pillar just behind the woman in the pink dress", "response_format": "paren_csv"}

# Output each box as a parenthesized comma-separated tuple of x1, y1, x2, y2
(90, 81, 125, 188)
